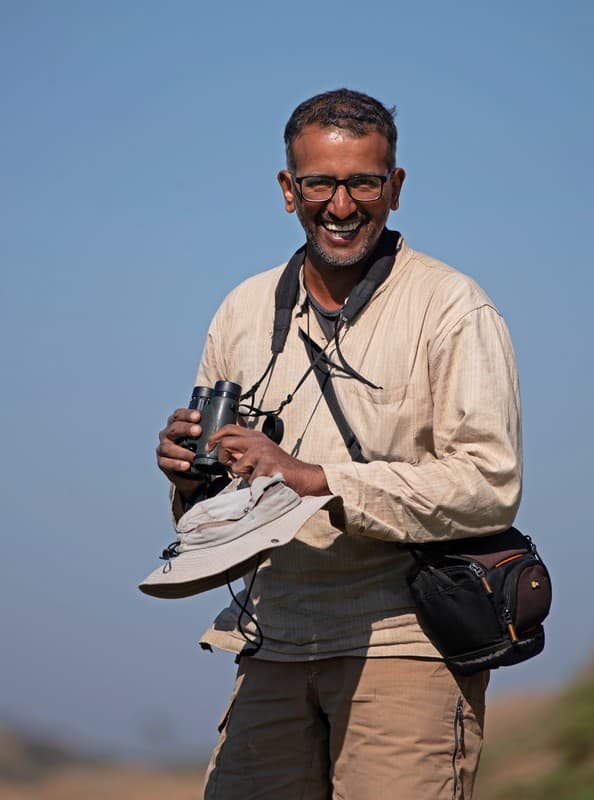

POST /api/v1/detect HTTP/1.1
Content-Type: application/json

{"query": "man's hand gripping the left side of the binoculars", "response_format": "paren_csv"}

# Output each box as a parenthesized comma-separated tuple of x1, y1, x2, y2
(157, 408, 202, 498)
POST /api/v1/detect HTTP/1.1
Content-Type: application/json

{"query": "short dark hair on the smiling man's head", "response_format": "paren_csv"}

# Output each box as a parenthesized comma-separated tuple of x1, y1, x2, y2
(285, 89, 398, 171)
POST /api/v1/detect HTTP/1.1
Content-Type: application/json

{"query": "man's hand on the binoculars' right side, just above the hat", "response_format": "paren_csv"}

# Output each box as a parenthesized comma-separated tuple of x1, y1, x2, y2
(208, 425, 330, 497)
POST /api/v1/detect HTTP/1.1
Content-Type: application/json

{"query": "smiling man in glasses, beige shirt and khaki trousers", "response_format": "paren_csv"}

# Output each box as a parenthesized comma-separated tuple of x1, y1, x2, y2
(157, 89, 521, 800)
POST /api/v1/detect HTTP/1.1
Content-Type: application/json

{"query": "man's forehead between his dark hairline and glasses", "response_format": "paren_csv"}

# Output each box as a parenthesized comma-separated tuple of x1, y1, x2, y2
(292, 125, 389, 178)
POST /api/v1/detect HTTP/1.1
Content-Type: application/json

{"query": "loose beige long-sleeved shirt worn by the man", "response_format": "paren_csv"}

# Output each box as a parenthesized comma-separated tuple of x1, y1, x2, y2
(174, 234, 521, 660)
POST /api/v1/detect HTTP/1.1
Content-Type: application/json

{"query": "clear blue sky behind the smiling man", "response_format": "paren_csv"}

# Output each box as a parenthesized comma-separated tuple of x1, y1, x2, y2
(0, 0, 594, 754)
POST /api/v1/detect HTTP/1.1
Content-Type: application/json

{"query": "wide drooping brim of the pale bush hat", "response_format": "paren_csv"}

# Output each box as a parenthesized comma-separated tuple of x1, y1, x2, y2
(138, 495, 339, 599)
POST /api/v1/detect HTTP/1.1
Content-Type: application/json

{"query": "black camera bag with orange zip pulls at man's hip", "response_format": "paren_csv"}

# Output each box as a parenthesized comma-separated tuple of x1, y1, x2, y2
(409, 528, 551, 675)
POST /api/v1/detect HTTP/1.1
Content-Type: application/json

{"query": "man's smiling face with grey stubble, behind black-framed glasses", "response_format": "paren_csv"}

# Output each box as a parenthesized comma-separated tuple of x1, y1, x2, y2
(278, 125, 405, 268)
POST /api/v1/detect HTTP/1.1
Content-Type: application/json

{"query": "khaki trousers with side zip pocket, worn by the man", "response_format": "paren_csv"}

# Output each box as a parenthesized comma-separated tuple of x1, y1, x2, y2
(204, 657, 488, 800)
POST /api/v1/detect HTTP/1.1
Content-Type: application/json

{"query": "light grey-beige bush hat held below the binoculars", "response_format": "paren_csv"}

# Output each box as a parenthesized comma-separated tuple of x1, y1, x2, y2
(138, 473, 340, 598)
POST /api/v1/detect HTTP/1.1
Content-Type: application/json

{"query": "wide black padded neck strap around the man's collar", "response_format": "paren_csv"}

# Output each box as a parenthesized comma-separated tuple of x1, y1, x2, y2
(271, 229, 402, 355)
